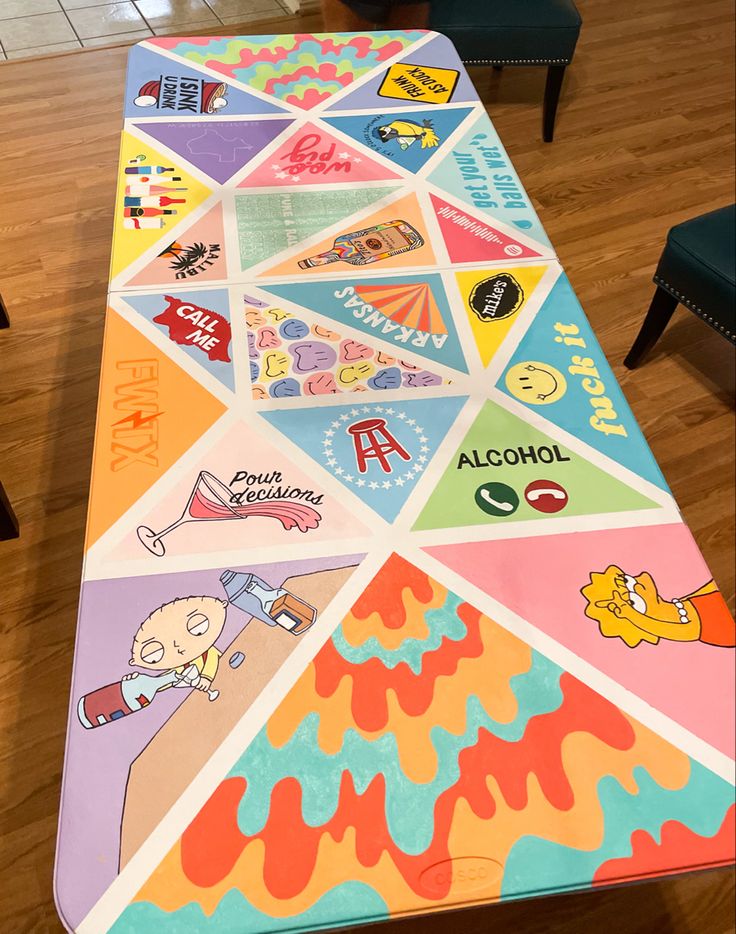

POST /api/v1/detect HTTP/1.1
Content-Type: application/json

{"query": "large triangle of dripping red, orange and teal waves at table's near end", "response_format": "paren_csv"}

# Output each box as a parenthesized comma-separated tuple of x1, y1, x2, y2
(113, 554, 734, 934)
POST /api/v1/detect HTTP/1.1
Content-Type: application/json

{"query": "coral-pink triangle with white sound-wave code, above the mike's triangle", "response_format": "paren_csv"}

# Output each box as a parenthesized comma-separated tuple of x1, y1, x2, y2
(430, 193, 546, 263)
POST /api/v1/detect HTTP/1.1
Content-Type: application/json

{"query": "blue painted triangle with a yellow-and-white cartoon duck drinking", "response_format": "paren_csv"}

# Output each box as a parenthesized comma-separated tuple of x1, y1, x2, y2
(323, 107, 472, 172)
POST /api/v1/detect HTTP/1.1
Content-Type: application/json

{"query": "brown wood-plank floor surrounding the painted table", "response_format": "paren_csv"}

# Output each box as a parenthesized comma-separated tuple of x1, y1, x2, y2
(0, 0, 734, 934)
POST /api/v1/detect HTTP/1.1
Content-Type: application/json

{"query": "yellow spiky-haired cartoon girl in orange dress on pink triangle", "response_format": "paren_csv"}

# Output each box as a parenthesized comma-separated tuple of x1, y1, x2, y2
(581, 564, 736, 648)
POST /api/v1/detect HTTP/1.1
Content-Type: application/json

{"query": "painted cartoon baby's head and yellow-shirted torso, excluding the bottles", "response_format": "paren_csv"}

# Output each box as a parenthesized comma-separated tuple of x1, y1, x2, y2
(123, 597, 227, 700)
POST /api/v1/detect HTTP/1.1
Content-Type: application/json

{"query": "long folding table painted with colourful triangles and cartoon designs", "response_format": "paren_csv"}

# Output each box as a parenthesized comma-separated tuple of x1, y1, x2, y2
(56, 32, 734, 932)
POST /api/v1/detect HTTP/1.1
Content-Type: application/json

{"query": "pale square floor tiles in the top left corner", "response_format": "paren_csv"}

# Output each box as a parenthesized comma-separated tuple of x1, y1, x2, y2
(0, 0, 291, 61)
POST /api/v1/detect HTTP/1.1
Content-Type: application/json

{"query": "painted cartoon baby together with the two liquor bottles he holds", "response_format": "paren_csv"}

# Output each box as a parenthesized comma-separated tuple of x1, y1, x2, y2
(77, 571, 317, 729)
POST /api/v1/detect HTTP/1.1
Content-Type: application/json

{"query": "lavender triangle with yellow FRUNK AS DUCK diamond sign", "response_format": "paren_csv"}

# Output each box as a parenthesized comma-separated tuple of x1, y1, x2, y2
(328, 35, 478, 113)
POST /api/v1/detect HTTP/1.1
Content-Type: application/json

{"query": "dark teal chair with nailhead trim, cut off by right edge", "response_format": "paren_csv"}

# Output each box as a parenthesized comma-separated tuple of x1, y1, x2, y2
(624, 204, 736, 370)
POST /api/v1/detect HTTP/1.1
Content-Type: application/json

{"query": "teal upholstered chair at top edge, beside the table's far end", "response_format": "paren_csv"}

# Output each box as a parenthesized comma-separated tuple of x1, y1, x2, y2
(431, 0, 582, 143)
